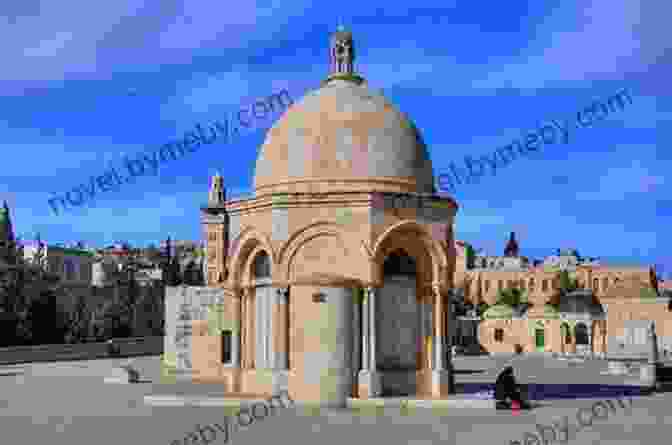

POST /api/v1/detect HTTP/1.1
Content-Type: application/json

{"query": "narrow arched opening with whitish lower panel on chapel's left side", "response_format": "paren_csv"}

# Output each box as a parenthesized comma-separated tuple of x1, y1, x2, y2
(252, 251, 275, 369)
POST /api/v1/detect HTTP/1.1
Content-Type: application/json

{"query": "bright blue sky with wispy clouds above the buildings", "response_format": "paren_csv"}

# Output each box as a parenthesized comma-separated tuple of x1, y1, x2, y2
(0, 0, 672, 276)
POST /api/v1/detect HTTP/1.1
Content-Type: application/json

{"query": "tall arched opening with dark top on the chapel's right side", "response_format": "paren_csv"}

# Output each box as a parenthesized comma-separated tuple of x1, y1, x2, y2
(376, 249, 420, 395)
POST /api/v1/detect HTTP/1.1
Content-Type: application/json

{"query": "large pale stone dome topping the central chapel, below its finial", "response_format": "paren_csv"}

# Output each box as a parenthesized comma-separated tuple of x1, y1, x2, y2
(255, 77, 435, 195)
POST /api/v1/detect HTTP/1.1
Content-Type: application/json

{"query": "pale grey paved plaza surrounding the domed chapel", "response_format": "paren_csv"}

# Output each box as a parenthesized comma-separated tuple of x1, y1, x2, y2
(0, 357, 672, 445)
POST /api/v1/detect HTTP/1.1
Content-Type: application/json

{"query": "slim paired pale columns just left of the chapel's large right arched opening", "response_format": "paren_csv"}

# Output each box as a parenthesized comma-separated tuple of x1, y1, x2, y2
(358, 287, 382, 399)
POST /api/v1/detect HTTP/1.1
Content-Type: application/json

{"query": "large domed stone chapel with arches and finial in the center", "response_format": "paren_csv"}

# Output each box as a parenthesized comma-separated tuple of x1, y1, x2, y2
(172, 28, 458, 406)
